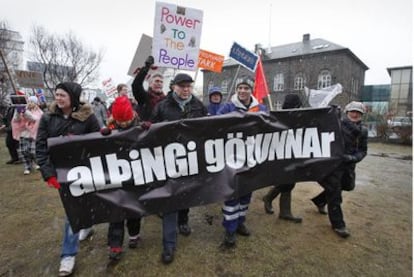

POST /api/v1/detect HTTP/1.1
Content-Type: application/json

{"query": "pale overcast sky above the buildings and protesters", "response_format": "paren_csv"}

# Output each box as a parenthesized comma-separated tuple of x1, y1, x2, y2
(0, 0, 413, 87)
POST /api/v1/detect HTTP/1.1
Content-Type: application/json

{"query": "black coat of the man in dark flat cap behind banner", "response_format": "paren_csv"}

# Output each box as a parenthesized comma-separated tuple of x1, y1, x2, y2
(151, 93, 207, 123)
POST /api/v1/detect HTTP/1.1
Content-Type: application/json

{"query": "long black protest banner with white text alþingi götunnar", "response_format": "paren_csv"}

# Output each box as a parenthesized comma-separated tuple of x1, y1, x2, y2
(48, 107, 343, 231)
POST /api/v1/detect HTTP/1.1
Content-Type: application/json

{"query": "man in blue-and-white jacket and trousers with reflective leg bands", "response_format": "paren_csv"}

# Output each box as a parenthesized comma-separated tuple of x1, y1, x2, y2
(218, 78, 267, 247)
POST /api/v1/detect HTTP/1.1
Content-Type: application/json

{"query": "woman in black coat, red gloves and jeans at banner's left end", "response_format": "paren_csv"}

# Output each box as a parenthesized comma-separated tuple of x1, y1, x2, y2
(36, 82, 100, 276)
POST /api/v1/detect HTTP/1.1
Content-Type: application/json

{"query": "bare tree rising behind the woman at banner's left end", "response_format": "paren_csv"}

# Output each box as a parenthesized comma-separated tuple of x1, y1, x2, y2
(30, 26, 103, 93)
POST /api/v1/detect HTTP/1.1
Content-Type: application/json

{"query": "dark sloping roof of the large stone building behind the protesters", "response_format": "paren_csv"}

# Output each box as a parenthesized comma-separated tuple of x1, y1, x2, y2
(223, 38, 368, 69)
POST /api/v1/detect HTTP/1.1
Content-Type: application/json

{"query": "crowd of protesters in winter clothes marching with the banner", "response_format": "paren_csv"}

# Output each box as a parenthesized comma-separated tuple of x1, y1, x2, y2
(1, 56, 367, 276)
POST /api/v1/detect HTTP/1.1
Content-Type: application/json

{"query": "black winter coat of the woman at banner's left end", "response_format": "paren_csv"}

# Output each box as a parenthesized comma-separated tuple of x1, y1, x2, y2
(36, 103, 100, 181)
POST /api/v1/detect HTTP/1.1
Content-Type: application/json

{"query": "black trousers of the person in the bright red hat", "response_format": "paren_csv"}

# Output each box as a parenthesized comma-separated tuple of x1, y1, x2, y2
(108, 218, 141, 247)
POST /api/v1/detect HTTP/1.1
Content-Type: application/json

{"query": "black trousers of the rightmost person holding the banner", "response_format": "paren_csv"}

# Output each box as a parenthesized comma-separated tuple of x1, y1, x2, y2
(312, 167, 345, 228)
